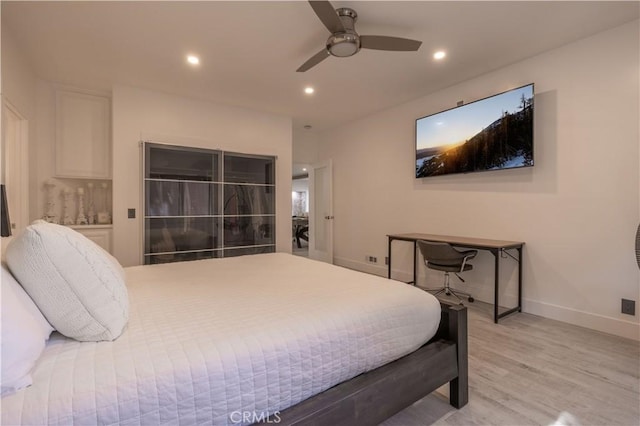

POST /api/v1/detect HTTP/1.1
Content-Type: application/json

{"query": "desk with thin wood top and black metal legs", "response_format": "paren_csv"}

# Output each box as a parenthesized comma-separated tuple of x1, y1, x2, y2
(387, 234, 524, 323)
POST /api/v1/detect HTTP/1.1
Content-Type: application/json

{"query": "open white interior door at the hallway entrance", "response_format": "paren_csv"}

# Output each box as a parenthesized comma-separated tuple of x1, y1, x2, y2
(309, 160, 333, 263)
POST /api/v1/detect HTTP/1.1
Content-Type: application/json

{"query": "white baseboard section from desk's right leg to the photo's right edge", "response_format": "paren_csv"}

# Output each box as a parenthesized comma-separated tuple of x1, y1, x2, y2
(522, 299, 640, 340)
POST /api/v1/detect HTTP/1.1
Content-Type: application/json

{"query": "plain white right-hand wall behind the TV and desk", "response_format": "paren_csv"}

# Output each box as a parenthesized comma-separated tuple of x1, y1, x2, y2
(319, 21, 640, 339)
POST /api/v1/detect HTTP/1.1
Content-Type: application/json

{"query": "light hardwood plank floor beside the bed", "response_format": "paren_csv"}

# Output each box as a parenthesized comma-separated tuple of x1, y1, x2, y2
(383, 302, 640, 426)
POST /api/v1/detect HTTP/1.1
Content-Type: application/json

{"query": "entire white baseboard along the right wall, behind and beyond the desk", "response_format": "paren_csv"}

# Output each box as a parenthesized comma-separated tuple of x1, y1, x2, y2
(333, 257, 640, 341)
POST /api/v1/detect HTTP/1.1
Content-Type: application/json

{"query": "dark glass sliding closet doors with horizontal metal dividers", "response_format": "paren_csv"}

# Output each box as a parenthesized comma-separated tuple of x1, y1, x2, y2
(144, 142, 275, 264)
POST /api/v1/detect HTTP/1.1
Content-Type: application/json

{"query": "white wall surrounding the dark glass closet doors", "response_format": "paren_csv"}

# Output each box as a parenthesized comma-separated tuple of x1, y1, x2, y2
(113, 85, 292, 266)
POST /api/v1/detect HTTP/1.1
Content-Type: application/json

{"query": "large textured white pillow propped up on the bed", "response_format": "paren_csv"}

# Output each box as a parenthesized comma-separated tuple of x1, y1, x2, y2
(7, 221, 129, 342)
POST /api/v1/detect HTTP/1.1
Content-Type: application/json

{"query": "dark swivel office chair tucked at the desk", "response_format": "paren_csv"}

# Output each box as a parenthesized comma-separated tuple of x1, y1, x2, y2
(418, 240, 478, 305)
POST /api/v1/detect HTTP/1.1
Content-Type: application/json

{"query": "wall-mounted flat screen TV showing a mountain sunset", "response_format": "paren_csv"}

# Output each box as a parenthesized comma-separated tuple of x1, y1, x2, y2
(416, 84, 533, 178)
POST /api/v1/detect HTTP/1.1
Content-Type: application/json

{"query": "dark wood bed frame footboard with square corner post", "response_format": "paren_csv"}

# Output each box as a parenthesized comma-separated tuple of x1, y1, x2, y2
(267, 302, 469, 425)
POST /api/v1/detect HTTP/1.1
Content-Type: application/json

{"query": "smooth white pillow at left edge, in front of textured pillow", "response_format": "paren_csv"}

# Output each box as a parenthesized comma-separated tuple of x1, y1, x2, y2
(0, 264, 53, 396)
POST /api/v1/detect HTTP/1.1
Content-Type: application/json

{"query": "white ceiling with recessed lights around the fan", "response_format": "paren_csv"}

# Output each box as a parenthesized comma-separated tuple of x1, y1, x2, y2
(1, 1, 640, 131)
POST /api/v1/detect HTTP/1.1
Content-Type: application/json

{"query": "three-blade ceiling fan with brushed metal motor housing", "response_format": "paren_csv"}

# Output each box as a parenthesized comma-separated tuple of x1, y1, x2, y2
(296, 0, 422, 72)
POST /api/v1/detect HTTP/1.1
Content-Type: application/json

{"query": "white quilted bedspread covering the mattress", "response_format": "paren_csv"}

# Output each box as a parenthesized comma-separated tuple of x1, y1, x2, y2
(2, 253, 440, 425)
